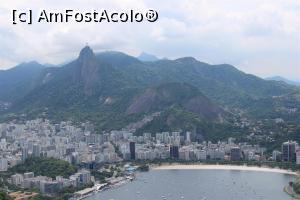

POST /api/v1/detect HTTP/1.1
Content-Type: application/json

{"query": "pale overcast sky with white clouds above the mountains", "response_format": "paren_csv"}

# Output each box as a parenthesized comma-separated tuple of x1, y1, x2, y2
(0, 0, 300, 80)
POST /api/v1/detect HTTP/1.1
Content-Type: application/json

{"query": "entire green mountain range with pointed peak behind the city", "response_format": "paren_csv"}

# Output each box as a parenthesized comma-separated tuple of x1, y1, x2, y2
(0, 46, 300, 141)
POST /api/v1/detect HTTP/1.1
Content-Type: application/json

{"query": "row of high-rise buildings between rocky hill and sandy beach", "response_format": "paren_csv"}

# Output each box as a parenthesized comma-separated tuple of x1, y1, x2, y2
(114, 131, 266, 161)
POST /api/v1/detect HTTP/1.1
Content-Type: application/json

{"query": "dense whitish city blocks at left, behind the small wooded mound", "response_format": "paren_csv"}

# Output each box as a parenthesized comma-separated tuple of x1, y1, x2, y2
(0, 119, 121, 171)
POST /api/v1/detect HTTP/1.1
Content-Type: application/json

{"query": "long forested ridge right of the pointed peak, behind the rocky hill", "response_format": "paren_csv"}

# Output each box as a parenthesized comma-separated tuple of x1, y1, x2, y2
(97, 52, 297, 107)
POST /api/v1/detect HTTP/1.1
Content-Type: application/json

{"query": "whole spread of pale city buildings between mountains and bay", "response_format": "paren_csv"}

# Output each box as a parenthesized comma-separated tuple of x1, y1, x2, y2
(0, 119, 300, 193)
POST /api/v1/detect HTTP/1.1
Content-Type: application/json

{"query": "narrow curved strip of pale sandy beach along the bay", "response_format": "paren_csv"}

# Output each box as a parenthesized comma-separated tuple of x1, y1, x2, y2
(152, 164, 297, 175)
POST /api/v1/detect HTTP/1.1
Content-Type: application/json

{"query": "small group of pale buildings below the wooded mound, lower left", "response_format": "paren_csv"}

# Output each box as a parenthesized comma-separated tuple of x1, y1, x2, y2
(8, 170, 92, 194)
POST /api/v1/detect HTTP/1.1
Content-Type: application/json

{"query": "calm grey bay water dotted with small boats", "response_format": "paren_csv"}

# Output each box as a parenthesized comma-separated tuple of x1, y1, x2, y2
(88, 170, 293, 200)
